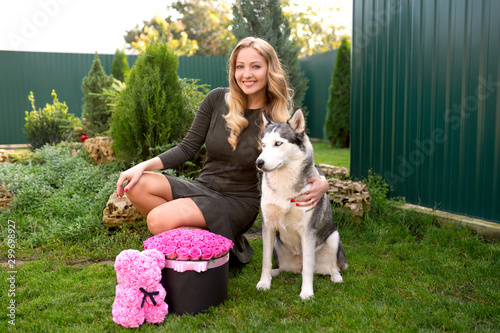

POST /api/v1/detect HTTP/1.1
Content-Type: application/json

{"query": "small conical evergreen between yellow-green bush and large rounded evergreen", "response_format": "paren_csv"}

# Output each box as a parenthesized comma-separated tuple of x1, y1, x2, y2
(82, 52, 113, 136)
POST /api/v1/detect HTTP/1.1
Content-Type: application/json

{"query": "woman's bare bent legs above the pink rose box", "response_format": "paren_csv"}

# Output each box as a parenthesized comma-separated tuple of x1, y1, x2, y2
(127, 172, 207, 235)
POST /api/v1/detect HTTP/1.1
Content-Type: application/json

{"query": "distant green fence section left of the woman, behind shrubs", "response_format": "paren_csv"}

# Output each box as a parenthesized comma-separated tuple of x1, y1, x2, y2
(0, 51, 227, 144)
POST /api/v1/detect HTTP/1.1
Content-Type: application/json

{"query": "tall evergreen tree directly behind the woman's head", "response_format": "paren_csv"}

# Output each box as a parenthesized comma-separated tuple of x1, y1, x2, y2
(233, 0, 308, 106)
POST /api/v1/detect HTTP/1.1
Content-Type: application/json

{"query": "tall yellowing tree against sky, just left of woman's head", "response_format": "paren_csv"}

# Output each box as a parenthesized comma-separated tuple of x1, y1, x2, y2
(171, 0, 235, 56)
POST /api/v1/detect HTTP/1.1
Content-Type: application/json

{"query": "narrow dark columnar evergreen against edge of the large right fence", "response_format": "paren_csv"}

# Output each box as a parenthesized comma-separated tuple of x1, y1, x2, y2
(325, 38, 351, 147)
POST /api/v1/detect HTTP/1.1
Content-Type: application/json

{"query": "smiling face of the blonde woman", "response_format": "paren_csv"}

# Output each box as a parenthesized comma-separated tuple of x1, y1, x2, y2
(234, 47, 268, 109)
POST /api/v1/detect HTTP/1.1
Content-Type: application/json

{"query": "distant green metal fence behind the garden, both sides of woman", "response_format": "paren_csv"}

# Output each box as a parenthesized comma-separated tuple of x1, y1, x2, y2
(0, 51, 335, 145)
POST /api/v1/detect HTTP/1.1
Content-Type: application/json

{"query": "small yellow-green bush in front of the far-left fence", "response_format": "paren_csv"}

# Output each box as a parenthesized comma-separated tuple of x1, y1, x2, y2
(24, 90, 81, 150)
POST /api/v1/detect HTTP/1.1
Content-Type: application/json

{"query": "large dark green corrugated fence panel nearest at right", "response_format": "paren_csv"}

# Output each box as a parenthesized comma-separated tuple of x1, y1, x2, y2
(351, 0, 500, 222)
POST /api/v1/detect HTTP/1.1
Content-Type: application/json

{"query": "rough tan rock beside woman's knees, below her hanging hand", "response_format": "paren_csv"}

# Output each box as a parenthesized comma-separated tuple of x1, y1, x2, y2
(102, 191, 146, 228)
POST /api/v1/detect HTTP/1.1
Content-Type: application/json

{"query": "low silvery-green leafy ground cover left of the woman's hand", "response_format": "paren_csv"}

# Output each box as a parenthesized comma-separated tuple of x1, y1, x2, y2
(0, 145, 118, 247)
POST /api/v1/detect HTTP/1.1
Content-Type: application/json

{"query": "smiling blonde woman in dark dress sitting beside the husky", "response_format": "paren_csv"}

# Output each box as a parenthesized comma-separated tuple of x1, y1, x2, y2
(116, 37, 328, 263)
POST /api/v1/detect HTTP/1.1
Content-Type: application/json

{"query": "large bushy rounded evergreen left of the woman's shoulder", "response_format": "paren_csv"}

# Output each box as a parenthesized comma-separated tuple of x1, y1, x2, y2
(111, 42, 187, 162)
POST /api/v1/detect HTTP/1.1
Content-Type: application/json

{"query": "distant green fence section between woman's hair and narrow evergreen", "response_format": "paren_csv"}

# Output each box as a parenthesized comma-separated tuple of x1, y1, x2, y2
(299, 50, 337, 139)
